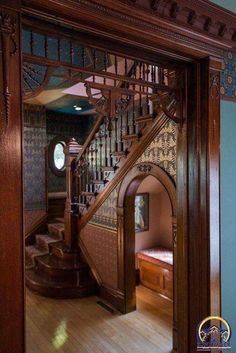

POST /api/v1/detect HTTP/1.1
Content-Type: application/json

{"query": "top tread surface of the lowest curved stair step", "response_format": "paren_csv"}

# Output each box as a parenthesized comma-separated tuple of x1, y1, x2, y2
(25, 269, 95, 290)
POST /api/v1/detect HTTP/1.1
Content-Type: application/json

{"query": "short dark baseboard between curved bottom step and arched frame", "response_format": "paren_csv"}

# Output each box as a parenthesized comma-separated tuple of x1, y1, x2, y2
(99, 284, 125, 314)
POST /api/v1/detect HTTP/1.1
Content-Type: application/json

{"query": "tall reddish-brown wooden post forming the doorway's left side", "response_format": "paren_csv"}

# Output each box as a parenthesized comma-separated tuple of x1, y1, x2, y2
(0, 0, 25, 353)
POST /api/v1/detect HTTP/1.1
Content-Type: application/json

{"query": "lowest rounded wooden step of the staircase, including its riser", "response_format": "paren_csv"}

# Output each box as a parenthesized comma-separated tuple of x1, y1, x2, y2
(25, 269, 97, 299)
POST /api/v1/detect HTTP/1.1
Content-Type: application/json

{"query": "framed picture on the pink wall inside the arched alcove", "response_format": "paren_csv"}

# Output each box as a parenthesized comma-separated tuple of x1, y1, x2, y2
(134, 192, 149, 233)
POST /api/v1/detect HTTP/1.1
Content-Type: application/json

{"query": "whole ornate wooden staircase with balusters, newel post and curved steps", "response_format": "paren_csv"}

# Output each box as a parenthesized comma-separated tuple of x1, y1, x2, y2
(26, 62, 182, 298)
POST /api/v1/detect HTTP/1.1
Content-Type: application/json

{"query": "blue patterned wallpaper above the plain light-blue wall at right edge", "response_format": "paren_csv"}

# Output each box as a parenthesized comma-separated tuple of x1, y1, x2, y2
(221, 52, 236, 101)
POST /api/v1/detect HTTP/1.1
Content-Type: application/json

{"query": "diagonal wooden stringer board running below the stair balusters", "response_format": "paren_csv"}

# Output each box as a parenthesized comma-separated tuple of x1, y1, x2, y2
(78, 106, 172, 231)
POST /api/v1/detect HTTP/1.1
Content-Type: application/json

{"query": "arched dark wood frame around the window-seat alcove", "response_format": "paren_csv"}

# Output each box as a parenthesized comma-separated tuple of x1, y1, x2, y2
(117, 163, 177, 350)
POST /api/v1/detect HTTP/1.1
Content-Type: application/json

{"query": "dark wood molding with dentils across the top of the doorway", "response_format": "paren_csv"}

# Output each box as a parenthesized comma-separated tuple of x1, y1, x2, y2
(22, 0, 236, 58)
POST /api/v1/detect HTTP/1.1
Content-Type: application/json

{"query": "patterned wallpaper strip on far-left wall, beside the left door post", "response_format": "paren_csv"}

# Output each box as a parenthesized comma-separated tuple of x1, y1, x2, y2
(24, 104, 47, 210)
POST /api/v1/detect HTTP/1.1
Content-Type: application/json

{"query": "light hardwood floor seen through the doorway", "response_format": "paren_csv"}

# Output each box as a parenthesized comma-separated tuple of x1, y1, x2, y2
(26, 286, 172, 353)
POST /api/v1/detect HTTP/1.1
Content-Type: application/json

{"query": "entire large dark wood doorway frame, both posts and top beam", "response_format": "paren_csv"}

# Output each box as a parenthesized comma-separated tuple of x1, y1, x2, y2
(0, 0, 223, 353)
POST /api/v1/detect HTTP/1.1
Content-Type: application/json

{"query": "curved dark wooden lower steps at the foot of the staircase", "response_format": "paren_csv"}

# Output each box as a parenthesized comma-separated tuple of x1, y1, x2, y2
(25, 219, 97, 298)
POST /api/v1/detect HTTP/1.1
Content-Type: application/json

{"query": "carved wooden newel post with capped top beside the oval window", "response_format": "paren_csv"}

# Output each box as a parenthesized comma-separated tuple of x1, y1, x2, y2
(64, 138, 82, 250)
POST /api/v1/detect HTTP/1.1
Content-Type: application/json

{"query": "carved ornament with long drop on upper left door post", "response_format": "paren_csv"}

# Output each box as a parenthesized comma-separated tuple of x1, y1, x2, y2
(0, 11, 17, 132)
